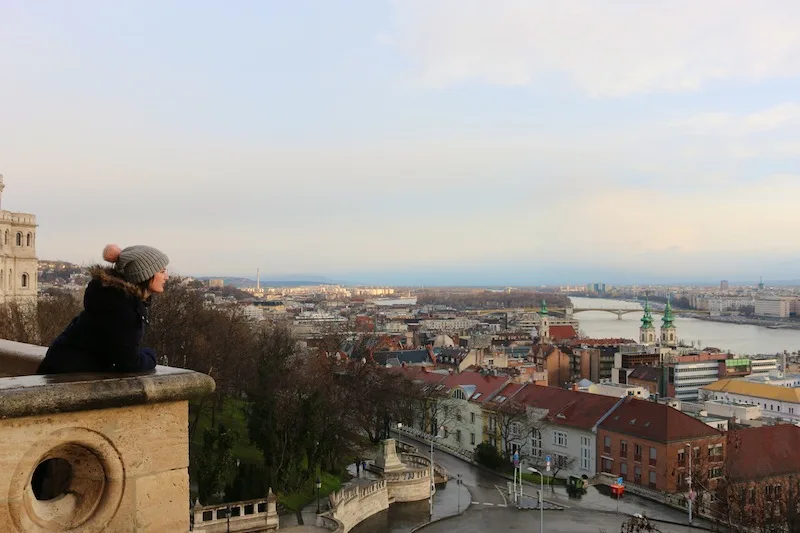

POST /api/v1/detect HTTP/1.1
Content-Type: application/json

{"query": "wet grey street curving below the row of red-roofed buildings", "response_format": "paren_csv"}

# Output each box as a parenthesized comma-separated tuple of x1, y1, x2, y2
(352, 435, 711, 533)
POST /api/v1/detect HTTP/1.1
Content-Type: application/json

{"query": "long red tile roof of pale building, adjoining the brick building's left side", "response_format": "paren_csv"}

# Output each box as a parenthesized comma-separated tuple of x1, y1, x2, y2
(514, 384, 619, 429)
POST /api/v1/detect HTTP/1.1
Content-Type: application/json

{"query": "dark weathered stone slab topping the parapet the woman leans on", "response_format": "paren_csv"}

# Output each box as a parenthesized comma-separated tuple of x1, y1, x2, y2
(0, 366, 214, 419)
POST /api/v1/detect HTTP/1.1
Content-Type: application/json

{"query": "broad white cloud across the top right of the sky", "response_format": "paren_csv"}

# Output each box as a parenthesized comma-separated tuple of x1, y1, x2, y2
(395, 0, 800, 97)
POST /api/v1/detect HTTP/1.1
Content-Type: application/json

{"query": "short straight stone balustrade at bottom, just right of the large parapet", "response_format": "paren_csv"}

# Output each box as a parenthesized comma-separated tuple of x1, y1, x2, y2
(192, 490, 278, 533)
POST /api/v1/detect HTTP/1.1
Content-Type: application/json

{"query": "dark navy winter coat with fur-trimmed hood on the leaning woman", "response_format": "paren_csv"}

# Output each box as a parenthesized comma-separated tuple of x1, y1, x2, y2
(37, 267, 156, 374)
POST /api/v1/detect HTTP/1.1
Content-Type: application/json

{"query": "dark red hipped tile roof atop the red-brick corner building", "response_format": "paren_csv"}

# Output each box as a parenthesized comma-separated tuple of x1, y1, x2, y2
(599, 397, 722, 444)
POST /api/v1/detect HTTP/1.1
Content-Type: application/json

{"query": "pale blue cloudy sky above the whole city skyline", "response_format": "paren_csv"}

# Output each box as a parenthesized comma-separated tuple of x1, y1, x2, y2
(0, 0, 800, 284)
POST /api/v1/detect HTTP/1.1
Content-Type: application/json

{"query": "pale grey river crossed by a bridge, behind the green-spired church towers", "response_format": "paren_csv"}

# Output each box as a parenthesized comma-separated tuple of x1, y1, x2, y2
(570, 296, 800, 355)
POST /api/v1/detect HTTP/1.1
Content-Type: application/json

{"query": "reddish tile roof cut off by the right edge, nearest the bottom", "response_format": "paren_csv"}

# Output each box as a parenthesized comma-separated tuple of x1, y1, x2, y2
(727, 424, 800, 481)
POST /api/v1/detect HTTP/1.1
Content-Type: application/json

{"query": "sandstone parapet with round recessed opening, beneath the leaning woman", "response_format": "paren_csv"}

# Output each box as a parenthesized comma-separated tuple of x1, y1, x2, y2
(0, 341, 214, 533)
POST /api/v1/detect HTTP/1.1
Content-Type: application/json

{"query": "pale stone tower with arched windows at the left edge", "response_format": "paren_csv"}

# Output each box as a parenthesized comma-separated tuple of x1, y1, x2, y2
(0, 174, 39, 304)
